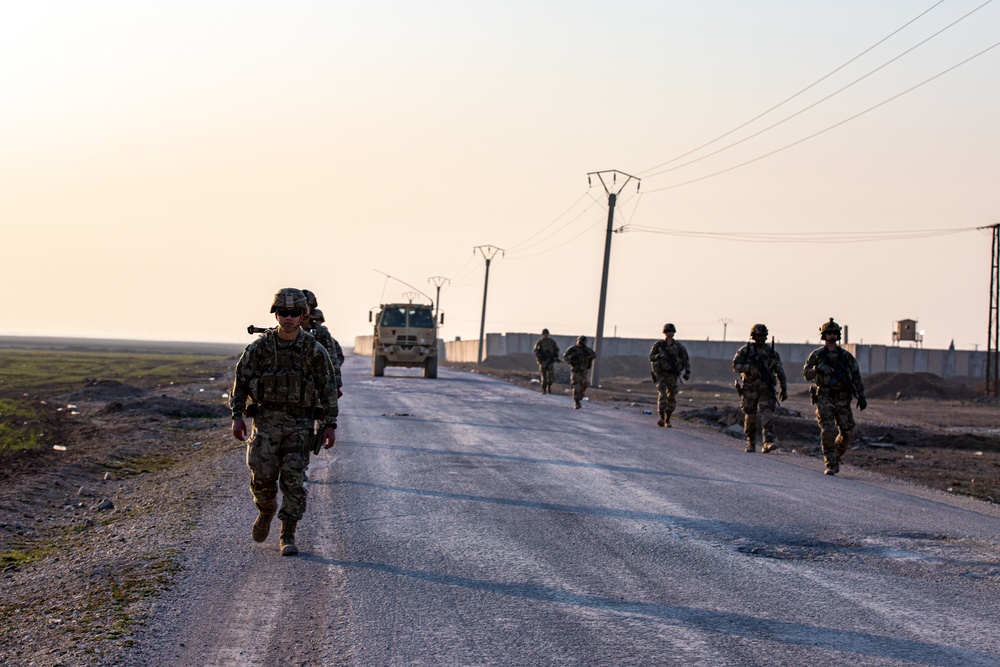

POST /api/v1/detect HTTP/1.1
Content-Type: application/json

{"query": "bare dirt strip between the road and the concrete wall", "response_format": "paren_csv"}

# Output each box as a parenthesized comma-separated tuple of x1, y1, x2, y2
(442, 354, 1000, 502)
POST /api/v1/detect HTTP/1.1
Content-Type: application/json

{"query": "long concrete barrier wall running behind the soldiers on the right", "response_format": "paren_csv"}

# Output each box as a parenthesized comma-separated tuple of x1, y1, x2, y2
(354, 332, 986, 379)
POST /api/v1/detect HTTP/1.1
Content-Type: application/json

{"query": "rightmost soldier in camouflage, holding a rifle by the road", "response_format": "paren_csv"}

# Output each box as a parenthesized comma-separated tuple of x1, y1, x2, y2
(802, 317, 868, 475)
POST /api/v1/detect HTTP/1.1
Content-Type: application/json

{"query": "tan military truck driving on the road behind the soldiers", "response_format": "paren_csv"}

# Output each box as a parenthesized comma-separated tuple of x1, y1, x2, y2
(368, 303, 444, 378)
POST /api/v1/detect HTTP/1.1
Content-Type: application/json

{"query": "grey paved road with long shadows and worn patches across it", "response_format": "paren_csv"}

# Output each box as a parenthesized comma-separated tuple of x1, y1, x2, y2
(135, 357, 1000, 667)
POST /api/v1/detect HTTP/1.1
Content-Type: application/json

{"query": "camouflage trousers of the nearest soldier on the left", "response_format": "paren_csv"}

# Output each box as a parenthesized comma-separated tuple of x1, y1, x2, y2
(247, 413, 313, 521)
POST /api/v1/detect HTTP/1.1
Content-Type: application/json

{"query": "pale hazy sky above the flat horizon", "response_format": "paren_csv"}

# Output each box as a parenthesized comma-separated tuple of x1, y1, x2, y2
(0, 0, 1000, 349)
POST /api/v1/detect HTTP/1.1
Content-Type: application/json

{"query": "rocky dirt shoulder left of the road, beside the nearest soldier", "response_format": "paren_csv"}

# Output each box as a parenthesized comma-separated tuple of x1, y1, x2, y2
(0, 360, 236, 665)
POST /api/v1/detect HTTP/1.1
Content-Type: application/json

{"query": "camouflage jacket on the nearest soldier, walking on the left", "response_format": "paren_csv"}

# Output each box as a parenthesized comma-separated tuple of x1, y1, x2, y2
(229, 329, 339, 425)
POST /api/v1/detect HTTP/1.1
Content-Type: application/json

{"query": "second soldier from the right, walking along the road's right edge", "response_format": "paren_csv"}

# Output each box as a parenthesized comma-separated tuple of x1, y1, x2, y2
(733, 324, 788, 454)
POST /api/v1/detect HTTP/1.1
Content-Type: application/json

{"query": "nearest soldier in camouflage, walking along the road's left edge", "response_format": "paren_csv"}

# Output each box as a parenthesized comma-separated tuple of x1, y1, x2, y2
(229, 287, 337, 556)
